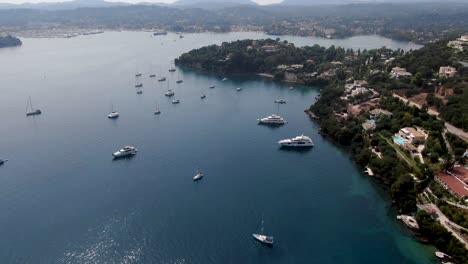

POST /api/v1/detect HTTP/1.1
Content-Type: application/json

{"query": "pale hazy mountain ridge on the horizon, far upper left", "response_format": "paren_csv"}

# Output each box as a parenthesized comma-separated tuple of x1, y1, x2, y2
(0, 0, 130, 10)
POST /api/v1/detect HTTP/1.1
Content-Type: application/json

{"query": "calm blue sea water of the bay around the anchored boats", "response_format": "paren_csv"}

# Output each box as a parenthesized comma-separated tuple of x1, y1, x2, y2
(0, 32, 435, 263)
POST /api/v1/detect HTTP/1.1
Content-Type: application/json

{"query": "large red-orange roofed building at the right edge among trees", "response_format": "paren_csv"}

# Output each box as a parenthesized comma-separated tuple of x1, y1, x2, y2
(436, 166, 468, 199)
